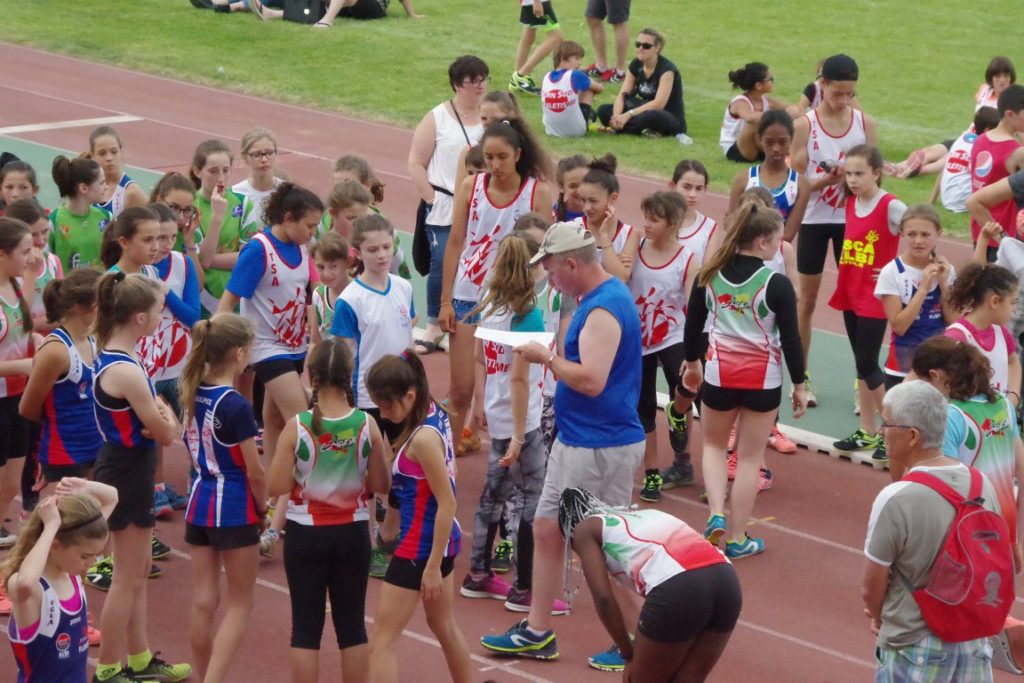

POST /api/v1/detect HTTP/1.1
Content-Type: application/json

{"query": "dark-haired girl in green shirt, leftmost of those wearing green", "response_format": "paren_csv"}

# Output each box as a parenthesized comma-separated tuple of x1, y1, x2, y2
(50, 155, 113, 272)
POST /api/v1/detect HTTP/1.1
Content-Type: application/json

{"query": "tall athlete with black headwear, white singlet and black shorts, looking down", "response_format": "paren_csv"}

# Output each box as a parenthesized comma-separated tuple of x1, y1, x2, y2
(792, 54, 878, 405)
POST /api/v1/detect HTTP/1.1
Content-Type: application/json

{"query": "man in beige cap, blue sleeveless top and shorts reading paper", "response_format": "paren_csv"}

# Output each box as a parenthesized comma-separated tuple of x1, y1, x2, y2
(481, 223, 644, 659)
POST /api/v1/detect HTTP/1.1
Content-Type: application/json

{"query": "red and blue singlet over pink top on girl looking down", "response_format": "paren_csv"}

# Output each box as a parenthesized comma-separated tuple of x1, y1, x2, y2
(391, 401, 462, 560)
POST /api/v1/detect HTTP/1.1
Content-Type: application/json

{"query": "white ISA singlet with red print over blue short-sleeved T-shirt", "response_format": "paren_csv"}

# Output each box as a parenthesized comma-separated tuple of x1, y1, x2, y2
(242, 232, 309, 362)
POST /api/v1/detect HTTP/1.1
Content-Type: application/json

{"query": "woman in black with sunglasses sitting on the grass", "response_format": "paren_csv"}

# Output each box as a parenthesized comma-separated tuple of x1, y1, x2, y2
(597, 29, 686, 136)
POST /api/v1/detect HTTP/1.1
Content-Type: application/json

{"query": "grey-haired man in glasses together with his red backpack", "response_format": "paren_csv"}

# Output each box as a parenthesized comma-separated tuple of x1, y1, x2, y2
(861, 381, 1014, 683)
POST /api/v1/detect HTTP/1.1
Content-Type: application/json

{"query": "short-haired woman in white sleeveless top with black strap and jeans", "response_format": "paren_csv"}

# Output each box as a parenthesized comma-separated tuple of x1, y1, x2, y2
(409, 54, 489, 353)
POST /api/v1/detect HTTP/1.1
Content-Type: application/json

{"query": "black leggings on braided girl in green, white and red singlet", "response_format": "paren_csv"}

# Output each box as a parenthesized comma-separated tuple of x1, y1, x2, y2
(285, 521, 370, 650)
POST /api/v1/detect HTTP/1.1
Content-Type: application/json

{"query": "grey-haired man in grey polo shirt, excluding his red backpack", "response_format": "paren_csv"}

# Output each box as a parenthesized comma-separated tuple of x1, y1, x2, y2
(861, 381, 998, 682)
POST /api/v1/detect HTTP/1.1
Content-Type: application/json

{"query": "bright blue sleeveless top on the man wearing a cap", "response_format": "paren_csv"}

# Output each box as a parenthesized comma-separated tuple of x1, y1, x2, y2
(555, 278, 644, 449)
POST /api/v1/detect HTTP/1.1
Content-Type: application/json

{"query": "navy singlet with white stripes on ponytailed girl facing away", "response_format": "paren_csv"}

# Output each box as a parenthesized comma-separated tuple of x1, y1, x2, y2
(184, 384, 259, 527)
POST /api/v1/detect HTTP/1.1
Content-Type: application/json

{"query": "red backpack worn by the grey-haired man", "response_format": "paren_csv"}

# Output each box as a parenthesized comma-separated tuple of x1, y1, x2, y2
(902, 467, 1014, 643)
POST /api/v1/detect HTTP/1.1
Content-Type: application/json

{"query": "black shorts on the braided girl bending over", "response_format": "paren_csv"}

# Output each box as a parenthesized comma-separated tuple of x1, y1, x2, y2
(637, 562, 743, 643)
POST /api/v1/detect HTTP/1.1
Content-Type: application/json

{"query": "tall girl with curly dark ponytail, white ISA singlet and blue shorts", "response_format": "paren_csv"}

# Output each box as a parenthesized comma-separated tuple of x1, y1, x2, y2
(438, 119, 553, 454)
